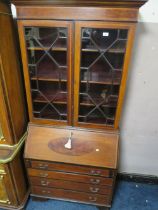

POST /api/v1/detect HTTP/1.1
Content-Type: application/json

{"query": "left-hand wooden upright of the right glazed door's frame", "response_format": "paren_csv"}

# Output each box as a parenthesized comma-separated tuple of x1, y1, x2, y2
(74, 22, 81, 126)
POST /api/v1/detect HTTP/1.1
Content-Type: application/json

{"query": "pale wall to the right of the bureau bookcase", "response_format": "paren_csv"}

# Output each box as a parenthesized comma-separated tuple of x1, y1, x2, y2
(120, 0, 158, 176)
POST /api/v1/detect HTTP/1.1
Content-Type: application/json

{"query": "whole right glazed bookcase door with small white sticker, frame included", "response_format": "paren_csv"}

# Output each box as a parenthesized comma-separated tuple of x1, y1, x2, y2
(74, 22, 135, 128)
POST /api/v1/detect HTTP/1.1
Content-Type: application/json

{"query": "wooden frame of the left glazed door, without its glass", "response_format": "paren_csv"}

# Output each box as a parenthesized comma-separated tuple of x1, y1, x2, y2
(18, 20, 73, 125)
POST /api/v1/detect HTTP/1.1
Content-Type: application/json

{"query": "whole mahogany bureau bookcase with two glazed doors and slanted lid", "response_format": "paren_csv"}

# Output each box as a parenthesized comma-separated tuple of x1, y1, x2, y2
(12, 0, 146, 209)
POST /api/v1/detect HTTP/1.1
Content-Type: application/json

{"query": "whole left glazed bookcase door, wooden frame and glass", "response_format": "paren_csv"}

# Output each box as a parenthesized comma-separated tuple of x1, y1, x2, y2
(18, 20, 72, 125)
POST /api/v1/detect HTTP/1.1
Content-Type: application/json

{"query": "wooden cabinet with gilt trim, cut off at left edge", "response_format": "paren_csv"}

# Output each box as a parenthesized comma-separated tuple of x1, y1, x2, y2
(0, 0, 29, 210)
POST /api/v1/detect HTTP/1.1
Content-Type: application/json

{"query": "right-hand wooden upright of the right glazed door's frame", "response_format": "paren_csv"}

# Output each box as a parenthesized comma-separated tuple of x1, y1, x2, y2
(114, 24, 136, 129)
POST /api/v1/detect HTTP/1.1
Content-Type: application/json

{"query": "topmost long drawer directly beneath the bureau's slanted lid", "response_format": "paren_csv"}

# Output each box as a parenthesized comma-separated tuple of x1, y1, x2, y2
(28, 161, 114, 177)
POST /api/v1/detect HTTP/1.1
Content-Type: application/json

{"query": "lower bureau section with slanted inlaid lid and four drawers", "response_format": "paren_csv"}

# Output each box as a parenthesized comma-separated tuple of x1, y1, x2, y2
(25, 125, 119, 206)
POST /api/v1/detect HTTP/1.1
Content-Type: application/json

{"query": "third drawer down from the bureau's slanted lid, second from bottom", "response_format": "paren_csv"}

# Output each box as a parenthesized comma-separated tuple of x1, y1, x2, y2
(30, 177, 112, 195)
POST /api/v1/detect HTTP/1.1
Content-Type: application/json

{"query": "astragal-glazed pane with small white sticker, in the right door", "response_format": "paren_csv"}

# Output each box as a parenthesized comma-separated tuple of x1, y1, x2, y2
(78, 28, 128, 126)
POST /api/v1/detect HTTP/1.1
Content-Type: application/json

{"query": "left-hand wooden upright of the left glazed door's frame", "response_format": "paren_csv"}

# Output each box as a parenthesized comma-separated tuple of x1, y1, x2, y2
(18, 20, 33, 120)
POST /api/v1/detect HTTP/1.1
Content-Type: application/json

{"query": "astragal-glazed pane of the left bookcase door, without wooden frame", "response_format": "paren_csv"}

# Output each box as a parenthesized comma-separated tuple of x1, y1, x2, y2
(25, 27, 68, 121)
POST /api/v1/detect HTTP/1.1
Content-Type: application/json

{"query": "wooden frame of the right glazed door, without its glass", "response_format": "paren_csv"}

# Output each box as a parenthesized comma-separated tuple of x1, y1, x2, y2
(74, 21, 136, 129)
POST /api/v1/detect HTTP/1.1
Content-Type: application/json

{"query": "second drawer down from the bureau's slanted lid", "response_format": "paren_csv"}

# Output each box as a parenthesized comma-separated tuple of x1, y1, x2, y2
(28, 168, 113, 186)
